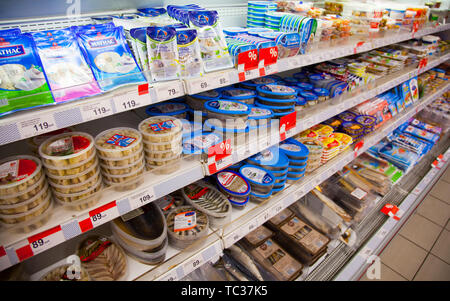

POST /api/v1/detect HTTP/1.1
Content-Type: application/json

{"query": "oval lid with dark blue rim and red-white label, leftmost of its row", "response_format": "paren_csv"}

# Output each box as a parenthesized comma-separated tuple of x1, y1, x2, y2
(216, 170, 250, 198)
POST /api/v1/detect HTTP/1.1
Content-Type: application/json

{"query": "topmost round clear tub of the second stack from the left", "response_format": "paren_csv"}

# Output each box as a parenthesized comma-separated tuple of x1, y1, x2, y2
(39, 132, 95, 168)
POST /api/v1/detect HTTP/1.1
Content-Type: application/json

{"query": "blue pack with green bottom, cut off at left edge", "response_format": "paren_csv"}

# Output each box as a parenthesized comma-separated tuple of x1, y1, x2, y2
(0, 32, 54, 116)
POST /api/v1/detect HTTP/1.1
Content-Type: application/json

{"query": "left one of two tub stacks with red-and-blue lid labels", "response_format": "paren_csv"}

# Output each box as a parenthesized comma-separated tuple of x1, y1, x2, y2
(95, 127, 145, 191)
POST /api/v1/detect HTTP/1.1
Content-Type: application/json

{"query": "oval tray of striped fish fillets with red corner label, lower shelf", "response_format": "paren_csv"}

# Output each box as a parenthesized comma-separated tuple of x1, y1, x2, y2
(181, 181, 231, 227)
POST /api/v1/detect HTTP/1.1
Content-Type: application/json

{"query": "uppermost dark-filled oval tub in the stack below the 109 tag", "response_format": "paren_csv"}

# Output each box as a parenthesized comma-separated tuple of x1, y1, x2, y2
(111, 203, 167, 253)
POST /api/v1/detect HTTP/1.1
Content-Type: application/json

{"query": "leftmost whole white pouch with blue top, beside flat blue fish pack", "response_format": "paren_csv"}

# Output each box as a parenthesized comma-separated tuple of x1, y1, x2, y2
(147, 26, 180, 82)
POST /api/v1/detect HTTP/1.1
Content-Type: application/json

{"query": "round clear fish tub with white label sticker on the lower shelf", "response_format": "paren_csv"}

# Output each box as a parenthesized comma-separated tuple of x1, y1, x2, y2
(166, 206, 209, 250)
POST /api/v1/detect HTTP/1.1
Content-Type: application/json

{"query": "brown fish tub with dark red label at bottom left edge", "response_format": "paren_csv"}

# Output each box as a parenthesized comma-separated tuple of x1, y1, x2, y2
(77, 236, 128, 281)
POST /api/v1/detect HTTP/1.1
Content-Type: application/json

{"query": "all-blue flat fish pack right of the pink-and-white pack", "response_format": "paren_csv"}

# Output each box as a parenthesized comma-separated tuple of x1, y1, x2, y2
(77, 27, 146, 91)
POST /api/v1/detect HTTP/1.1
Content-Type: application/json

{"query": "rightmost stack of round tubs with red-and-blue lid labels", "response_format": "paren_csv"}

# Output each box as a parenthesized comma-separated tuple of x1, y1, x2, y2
(138, 116, 183, 174)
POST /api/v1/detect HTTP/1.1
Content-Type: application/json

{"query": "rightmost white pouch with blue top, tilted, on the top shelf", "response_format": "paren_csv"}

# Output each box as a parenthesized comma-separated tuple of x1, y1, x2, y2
(189, 10, 233, 72)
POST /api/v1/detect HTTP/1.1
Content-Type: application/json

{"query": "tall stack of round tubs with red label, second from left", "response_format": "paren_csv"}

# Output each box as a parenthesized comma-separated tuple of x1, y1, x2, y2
(39, 132, 103, 210)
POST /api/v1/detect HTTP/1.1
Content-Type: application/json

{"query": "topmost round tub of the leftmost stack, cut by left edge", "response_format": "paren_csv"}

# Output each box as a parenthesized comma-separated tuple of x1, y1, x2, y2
(0, 155, 42, 197)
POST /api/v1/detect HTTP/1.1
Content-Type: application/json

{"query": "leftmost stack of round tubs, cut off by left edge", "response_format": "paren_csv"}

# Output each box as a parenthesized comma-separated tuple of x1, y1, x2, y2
(0, 156, 51, 232)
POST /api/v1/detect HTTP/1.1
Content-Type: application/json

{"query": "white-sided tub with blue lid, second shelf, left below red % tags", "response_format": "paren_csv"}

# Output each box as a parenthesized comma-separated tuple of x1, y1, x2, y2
(205, 99, 251, 129)
